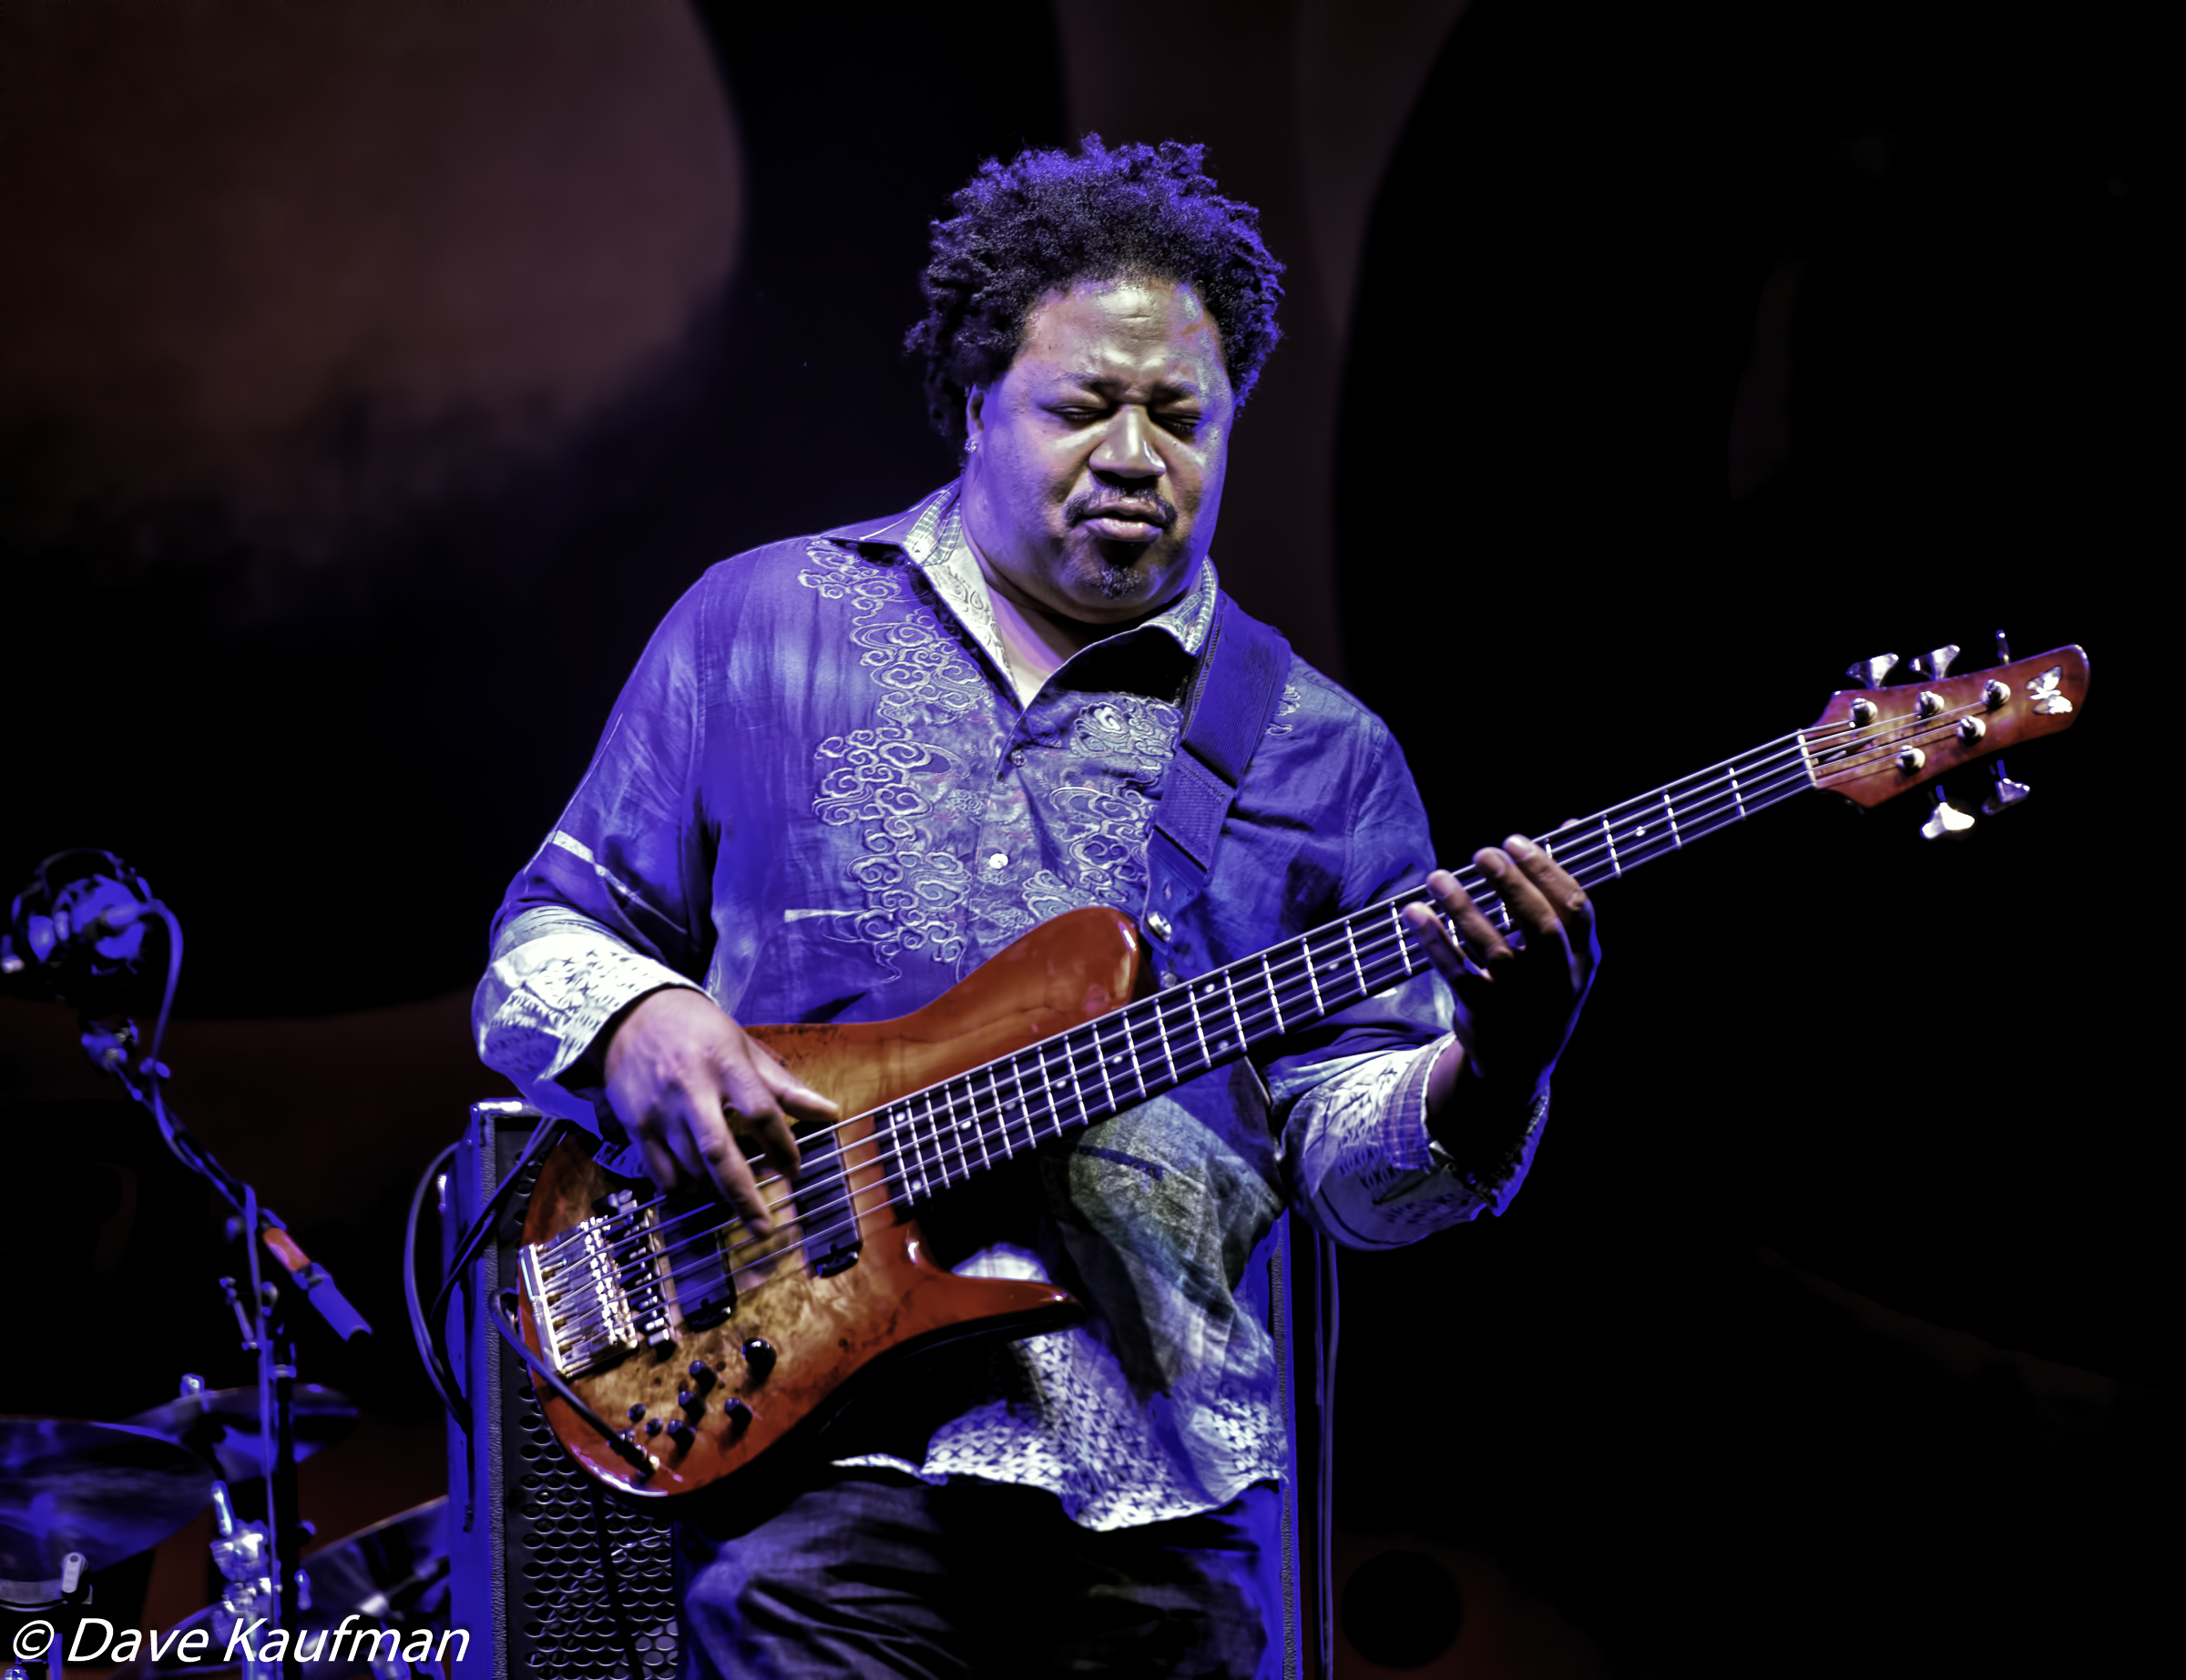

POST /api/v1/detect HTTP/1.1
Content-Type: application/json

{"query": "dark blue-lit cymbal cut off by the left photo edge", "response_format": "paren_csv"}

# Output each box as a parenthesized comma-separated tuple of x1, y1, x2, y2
(0, 1418, 212, 1597)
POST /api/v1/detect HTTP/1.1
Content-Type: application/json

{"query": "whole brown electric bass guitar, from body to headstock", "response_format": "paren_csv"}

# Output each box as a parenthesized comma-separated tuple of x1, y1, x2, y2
(512, 647, 2088, 1496)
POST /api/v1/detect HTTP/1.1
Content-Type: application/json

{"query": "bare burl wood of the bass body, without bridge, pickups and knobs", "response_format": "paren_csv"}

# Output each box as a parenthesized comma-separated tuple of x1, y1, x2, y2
(523, 909, 1139, 1499)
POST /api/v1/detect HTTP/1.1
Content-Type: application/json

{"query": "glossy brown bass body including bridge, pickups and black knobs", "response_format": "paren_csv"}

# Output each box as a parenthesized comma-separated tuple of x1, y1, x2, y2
(520, 909, 1141, 1496)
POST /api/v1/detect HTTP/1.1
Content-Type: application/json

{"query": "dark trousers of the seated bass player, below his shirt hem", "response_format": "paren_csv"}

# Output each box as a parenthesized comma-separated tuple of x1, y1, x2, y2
(678, 1471, 1283, 1680)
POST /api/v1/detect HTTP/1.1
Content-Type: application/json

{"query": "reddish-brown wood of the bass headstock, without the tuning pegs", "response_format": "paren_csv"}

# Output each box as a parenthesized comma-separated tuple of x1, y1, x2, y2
(1805, 647, 2088, 806)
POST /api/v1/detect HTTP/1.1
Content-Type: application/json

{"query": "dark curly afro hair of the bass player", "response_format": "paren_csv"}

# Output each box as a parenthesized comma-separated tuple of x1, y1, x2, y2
(903, 133, 1283, 442)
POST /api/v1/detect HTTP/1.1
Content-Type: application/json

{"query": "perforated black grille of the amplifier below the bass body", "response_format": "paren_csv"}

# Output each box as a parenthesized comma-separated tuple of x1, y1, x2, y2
(498, 1134, 676, 1680)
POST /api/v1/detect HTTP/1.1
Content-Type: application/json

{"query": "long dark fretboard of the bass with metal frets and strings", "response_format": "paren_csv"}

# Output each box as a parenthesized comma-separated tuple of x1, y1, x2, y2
(874, 732, 1845, 1199)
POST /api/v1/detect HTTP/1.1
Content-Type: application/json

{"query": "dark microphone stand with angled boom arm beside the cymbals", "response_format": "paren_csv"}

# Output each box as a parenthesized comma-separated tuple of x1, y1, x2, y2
(83, 1016, 372, 1680)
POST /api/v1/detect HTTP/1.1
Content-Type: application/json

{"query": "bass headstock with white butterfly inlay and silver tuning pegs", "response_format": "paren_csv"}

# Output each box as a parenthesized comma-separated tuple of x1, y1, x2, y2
(1799, 647, 2088, 806)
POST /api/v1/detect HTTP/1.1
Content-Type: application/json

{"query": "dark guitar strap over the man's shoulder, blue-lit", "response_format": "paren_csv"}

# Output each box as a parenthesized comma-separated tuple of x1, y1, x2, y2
(1139, 595, 1290, 985)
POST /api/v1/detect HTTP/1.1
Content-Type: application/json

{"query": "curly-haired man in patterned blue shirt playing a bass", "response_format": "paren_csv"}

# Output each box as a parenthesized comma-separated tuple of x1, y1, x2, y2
(475, 137, 1598, 1680)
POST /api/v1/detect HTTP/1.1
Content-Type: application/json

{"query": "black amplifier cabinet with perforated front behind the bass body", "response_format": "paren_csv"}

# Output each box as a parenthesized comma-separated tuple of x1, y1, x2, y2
(442, 1101, 676, 1680)
